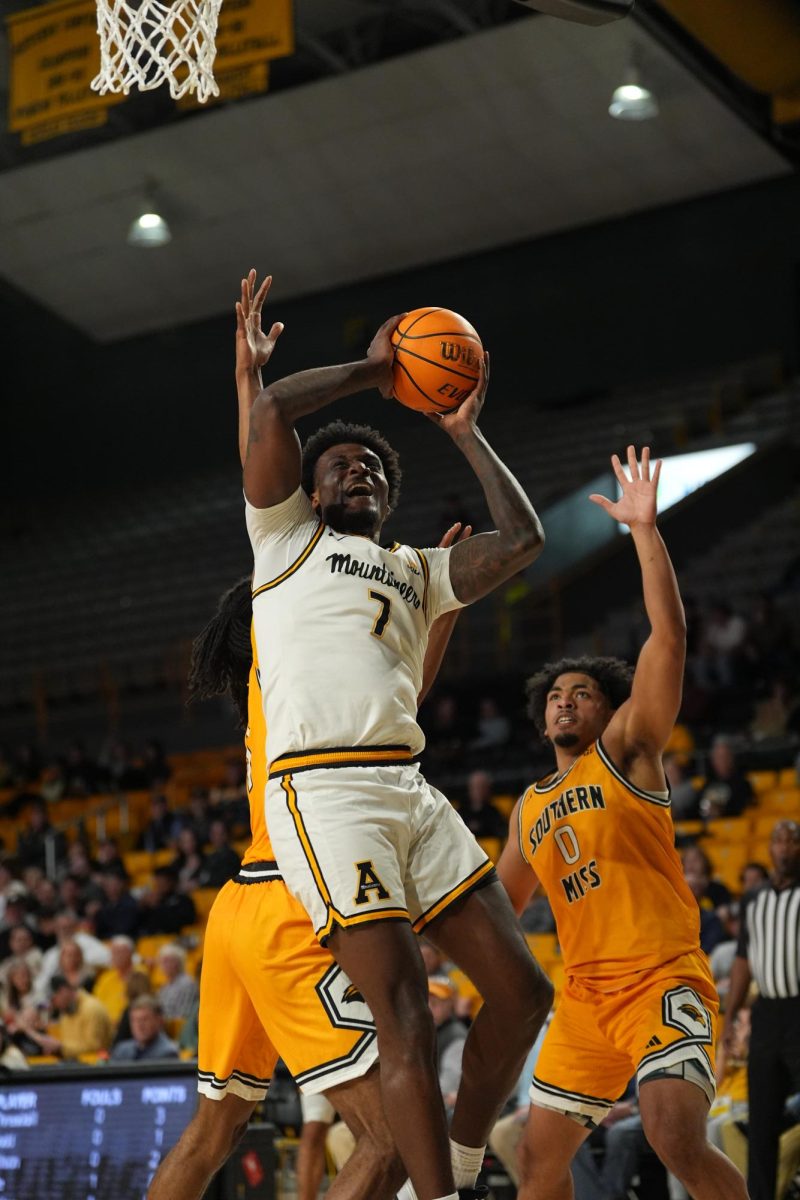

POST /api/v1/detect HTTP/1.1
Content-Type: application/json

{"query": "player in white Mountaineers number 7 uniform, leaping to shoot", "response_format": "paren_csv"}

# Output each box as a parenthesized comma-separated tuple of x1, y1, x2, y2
(240, 272, 552, 1200)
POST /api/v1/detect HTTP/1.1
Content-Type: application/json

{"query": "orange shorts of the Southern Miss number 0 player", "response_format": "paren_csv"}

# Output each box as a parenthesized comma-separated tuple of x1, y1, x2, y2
(530, 952, 720, 1124)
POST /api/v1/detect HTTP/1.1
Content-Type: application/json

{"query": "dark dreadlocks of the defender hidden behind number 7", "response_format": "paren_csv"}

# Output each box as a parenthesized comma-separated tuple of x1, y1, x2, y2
(188, 575, 253, 730)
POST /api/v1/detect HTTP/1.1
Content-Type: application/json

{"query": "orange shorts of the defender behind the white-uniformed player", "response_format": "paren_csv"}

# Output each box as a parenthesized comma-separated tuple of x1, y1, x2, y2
(198, 863, 378, 1100)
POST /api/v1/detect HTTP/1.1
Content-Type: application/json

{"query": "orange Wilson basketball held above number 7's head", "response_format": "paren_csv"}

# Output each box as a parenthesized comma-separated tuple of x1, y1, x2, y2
(392, 308, 483, 413)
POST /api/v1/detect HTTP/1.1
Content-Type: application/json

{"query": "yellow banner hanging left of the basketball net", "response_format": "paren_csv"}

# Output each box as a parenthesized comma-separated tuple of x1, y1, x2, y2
(6, 0, 123, 137)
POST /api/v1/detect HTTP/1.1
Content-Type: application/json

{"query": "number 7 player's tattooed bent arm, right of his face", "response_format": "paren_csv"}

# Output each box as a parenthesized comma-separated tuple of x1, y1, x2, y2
(428, 354, 545, 604)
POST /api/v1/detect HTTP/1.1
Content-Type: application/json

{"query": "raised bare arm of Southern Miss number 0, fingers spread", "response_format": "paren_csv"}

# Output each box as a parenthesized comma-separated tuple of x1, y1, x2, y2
(589, 446, 686, 758)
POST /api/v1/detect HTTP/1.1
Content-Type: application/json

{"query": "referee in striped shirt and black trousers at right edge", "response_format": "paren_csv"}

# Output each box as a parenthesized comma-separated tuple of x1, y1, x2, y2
(724, 821, 800, 1200)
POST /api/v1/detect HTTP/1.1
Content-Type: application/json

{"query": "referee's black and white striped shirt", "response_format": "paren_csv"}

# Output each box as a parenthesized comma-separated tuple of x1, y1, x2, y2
(736, 882, 800, 1000)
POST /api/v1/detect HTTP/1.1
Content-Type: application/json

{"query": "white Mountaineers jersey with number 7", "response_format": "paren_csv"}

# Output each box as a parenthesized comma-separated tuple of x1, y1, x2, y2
(246, 488, 461, 762)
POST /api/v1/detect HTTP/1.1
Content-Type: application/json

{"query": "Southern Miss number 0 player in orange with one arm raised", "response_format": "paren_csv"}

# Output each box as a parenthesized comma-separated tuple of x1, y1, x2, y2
(498, 446, 747, 1200)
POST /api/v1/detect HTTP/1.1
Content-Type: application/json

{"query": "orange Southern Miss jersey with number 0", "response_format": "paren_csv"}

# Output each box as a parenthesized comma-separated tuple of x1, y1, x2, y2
(519, 740, 700, 991)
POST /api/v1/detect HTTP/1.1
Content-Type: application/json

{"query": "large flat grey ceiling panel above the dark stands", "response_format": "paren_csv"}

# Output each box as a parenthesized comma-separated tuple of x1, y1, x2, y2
(0, 0, 790, 342)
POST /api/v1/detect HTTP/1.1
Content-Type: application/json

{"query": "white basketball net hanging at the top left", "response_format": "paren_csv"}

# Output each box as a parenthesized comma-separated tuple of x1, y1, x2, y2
(91, 0, 222, 102)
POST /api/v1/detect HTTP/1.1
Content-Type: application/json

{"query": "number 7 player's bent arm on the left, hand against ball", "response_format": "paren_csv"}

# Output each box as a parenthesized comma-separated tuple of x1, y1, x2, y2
(245, 316, 402, 509)
